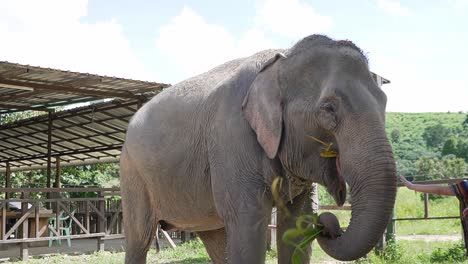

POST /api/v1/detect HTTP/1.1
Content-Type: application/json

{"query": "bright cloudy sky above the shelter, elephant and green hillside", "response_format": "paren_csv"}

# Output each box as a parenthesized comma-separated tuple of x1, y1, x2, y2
(0, 0, 468, 112)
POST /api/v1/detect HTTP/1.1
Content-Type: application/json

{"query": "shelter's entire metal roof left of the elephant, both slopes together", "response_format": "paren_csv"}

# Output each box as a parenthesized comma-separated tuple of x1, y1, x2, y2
(0, 62, 169, 187)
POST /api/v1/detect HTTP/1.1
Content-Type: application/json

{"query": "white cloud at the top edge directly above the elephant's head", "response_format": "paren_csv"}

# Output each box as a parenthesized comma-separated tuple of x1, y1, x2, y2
(255, 0, 332, 39)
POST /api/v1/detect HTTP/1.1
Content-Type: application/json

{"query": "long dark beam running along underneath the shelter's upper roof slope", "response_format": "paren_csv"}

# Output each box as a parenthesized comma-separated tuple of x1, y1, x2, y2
(0, 78, 138, 99)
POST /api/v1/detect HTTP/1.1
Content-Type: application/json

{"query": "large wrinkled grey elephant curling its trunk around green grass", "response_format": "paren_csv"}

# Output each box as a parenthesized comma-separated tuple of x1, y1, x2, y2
(121, 36, 396, 263)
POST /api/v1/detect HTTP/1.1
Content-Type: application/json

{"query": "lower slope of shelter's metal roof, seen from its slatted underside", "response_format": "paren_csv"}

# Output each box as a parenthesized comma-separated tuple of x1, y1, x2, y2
(0, 100, 138, 171)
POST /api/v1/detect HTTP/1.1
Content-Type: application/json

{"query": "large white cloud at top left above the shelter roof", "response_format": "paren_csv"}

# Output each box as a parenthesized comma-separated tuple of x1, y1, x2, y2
(0, 0, 157, 80)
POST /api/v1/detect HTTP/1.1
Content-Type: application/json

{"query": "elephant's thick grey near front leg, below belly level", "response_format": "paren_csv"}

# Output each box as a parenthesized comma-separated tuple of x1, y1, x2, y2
(224, 190, 272, 264)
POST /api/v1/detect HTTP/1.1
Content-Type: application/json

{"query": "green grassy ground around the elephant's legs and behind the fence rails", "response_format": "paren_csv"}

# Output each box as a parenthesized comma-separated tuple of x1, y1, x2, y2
(8, 188, 468, 264)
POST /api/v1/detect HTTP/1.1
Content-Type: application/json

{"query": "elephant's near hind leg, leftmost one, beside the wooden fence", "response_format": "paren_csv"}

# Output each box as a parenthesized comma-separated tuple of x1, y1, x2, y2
(120, 154, 158, 264)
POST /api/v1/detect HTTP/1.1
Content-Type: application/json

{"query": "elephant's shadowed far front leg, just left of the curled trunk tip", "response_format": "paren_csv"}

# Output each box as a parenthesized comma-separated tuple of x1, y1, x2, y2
(276, 191, 312, 264)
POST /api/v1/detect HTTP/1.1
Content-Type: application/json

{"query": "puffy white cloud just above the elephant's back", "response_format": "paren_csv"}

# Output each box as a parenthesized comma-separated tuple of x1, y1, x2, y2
(156, 6, 274, 81)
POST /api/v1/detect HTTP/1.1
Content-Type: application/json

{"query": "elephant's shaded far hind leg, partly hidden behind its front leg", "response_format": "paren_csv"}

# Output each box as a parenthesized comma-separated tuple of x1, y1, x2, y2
(198, 228, 227, 264)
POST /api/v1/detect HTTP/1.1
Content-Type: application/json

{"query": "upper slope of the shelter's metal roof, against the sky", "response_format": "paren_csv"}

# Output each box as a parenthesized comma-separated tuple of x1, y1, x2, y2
(0, 62, 169, 114)
